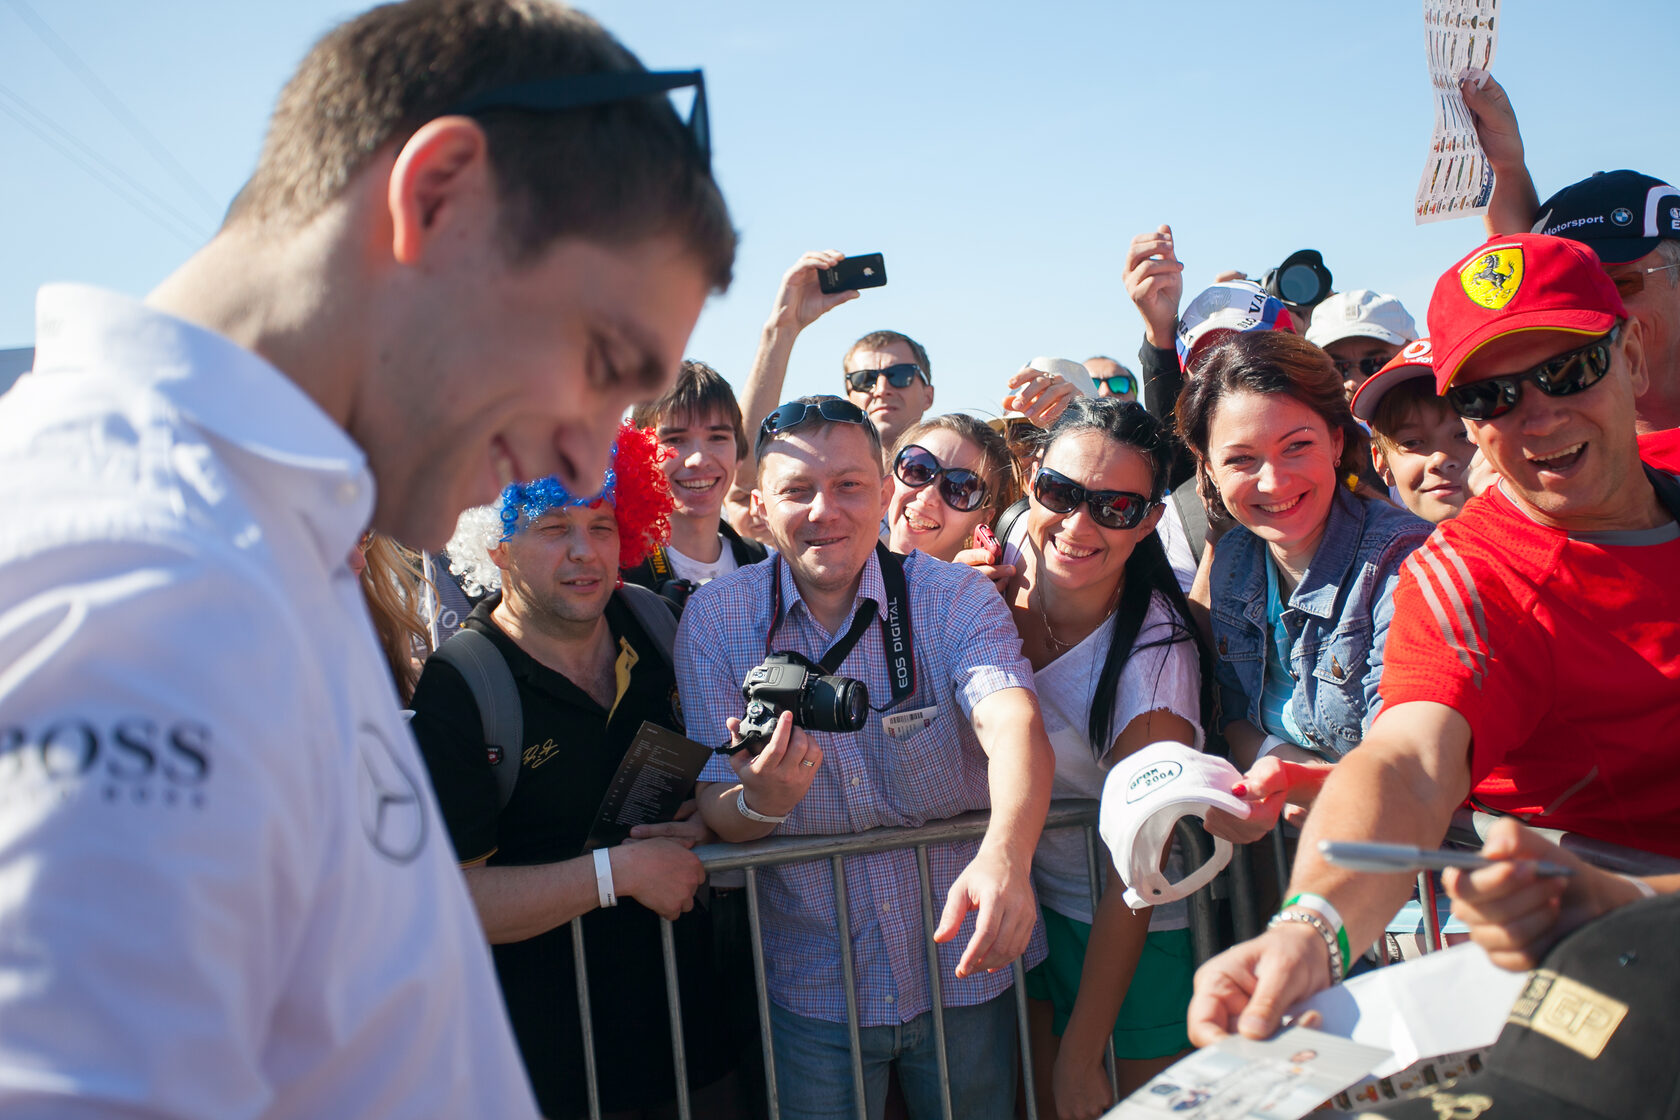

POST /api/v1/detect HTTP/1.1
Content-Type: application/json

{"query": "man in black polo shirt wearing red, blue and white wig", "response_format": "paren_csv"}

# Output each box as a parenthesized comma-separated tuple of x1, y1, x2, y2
(413, 427, 732, 1118)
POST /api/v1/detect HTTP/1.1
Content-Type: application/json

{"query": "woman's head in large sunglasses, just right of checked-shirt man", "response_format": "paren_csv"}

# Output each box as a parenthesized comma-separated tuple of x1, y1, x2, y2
(887, 413, 1020, 561)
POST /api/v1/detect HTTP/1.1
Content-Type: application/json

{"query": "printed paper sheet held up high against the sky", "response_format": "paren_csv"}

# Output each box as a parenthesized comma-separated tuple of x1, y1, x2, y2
(1416, 0, 1502, 225)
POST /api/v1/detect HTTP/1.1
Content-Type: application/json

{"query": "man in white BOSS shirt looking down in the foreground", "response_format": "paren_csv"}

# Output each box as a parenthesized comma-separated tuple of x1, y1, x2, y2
(0, 0, 734, 1120)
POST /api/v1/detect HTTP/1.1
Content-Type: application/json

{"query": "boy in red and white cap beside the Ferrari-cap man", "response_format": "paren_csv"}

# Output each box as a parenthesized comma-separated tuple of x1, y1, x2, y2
(1352, 338, 1475, 524)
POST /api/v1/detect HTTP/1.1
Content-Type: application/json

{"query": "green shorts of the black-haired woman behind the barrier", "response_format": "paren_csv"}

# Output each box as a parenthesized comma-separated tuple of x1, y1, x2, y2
(1026, 907, 1196, 1058)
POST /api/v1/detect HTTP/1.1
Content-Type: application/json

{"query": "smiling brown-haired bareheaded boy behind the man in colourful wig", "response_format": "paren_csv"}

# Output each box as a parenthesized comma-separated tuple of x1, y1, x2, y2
(623, 359, 766, 606)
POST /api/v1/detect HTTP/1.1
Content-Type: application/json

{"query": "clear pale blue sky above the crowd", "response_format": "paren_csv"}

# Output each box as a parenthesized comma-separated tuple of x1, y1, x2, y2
(0, 0, 1680, 410)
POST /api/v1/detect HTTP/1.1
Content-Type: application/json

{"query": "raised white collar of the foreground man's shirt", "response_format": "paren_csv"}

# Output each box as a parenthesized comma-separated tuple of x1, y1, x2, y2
(29, 284, 375, 568)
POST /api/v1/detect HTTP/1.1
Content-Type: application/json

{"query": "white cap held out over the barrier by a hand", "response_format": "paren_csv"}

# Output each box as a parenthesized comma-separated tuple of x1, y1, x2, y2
(1097, 742, 1250, 910)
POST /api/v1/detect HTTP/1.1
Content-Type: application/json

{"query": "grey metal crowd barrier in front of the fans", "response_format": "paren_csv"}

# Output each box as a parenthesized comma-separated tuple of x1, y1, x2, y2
(571, 799, 1252, 1120)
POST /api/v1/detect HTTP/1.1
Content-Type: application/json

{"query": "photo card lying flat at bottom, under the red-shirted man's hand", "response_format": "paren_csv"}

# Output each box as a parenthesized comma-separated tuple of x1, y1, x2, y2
(1104, 1026, 1388, 1120)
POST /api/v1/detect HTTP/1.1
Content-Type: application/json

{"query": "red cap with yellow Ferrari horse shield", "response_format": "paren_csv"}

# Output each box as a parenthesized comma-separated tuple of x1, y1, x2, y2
(1430, 233, 1628, 393)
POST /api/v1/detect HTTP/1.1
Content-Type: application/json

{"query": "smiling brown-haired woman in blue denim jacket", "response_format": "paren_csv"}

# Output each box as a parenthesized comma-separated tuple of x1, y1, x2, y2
(1178, 331, 1435, 841)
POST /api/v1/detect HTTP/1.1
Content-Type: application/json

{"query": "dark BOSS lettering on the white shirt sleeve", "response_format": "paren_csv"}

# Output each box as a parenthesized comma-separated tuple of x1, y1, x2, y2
(0, 715, 210, 809)
